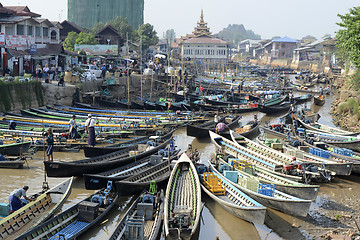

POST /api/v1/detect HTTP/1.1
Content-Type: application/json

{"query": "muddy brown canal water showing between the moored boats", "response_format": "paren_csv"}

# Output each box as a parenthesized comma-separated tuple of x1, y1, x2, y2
(0, 89, 360, 240)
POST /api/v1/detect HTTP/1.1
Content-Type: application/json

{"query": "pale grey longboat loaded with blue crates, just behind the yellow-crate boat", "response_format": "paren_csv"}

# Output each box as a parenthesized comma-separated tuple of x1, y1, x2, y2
(209, 162, 311, 217)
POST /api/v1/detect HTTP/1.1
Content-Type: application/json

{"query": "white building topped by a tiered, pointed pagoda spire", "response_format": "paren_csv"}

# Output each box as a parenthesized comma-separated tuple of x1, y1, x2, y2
(180, 10, 228, 63)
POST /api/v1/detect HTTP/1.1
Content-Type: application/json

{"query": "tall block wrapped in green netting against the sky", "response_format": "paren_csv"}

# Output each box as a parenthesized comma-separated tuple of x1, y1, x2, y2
(68, 0, 144, 29)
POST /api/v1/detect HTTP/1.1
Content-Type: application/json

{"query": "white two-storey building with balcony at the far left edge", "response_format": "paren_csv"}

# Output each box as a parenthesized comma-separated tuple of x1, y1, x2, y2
(0, 4, 62, 75)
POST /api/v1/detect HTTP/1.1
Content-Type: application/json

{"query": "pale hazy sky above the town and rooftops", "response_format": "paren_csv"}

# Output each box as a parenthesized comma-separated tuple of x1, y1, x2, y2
(0, 0, 360, 39)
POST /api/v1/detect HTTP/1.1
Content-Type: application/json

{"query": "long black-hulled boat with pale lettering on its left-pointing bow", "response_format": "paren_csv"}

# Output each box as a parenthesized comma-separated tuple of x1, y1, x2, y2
(44, 130, 175, 177)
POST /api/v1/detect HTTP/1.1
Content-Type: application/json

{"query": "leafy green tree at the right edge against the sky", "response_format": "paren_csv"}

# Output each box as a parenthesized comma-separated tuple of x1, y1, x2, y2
(335, 7, 360, 68)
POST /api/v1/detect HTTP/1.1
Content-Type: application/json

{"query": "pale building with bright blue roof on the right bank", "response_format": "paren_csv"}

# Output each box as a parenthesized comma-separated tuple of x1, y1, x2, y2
(264, 37, 298, 59)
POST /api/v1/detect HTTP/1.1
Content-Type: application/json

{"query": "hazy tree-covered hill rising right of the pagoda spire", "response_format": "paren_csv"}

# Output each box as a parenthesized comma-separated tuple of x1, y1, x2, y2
(216, 24, 261, 44)
